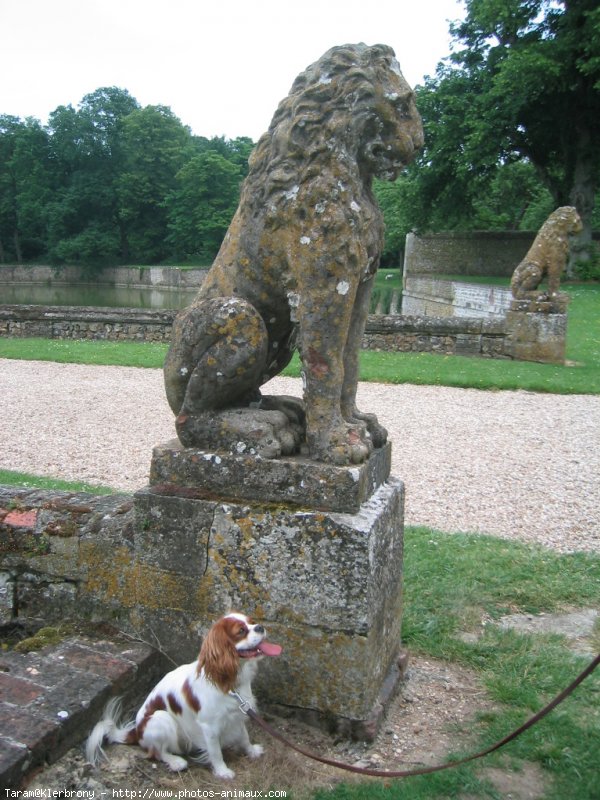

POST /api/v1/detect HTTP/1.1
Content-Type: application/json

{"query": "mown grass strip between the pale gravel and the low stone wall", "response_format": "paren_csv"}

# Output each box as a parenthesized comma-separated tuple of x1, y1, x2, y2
(0, 284, 600, 394)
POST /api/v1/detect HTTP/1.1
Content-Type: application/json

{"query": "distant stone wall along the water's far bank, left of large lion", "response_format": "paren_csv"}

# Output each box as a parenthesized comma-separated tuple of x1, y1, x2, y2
(0, 264, 208, 289)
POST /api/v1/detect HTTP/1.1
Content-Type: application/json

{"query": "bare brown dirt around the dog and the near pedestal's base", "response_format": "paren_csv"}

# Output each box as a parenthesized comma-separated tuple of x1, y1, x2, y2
(27, 657, 545, 800)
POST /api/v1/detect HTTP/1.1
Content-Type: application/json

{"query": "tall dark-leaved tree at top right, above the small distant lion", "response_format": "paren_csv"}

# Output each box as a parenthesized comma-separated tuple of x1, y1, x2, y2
(414, 0, 600, 270)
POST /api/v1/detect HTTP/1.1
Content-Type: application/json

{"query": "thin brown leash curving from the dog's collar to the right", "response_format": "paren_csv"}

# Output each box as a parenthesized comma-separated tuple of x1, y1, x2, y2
(237, 653, 600, 778)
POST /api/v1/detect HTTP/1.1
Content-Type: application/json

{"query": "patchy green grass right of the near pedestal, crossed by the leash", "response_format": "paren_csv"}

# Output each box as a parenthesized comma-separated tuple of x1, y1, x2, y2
(316, 528, 600, 800)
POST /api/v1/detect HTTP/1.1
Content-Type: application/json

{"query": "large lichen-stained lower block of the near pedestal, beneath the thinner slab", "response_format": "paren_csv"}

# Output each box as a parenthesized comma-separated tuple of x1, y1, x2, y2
(134, 476, 404, 728)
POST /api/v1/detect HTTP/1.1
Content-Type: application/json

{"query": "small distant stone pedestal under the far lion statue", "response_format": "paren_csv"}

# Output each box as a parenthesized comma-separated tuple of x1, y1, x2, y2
(506, 295, 568, 364)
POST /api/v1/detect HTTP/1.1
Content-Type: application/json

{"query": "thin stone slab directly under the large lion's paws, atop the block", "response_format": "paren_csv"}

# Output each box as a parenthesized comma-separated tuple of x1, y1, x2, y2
(150, 439, 392, 514)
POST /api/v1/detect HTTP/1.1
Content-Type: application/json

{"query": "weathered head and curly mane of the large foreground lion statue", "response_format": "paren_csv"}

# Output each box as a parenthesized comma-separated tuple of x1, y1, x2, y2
(250, 44, 423, 189)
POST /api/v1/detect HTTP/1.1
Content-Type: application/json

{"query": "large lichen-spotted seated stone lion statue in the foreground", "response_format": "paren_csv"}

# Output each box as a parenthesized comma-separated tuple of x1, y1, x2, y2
(164, 44, 423, 464)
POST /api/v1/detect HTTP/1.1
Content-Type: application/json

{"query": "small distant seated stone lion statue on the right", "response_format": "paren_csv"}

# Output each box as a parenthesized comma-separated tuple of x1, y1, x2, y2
(510, 206, 583, 300)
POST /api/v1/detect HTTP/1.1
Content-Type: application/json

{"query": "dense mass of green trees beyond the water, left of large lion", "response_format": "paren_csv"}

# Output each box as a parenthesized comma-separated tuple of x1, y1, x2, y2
(0, 87, 253, 269)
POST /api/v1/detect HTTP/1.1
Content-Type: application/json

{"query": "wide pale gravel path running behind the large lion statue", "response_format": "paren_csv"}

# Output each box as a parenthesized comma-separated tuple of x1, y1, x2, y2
(0, 359, 600, 552)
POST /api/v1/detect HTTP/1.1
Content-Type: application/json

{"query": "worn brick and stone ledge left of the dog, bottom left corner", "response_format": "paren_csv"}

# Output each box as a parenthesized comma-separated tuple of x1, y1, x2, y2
(0, 637, 166, 790)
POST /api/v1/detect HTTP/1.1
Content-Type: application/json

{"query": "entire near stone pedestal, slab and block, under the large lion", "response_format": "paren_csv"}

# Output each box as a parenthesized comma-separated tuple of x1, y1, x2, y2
(135, 440, 404, 736)
